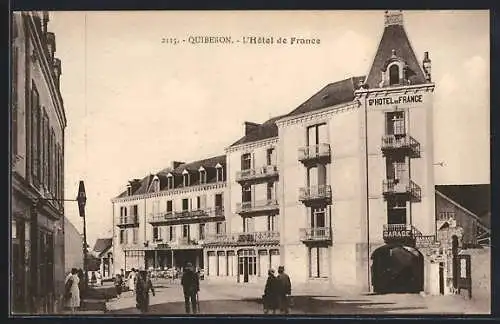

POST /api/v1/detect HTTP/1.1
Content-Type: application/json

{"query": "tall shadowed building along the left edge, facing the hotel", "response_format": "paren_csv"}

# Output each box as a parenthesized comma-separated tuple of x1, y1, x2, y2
(10, 11, 66, 314)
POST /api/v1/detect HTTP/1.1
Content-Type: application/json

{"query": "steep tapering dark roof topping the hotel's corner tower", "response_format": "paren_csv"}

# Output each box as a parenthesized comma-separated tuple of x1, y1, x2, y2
(365, 14, 427, 89)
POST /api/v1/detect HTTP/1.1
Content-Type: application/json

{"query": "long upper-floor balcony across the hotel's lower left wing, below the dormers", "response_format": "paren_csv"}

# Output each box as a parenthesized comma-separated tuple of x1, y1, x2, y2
(148, 207, 224, 225)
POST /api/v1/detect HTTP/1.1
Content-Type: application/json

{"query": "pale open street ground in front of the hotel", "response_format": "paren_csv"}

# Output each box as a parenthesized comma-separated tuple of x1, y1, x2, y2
(103, 281, 490, 315)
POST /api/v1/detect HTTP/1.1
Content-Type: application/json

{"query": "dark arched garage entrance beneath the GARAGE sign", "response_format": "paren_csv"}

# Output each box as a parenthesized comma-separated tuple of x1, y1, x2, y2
(371, 244, 424, 294)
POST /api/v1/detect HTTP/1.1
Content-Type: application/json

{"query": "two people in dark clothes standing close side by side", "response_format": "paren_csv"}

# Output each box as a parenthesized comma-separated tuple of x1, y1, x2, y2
(262, 266, 292, 314)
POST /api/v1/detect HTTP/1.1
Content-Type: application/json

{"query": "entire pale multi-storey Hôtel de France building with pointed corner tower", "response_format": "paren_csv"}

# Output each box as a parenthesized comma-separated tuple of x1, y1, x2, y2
(113, 11, 488, 294)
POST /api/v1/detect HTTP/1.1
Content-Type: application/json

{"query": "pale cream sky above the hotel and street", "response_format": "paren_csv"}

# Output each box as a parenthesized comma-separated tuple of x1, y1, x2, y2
(49, 11, 490, 246)
